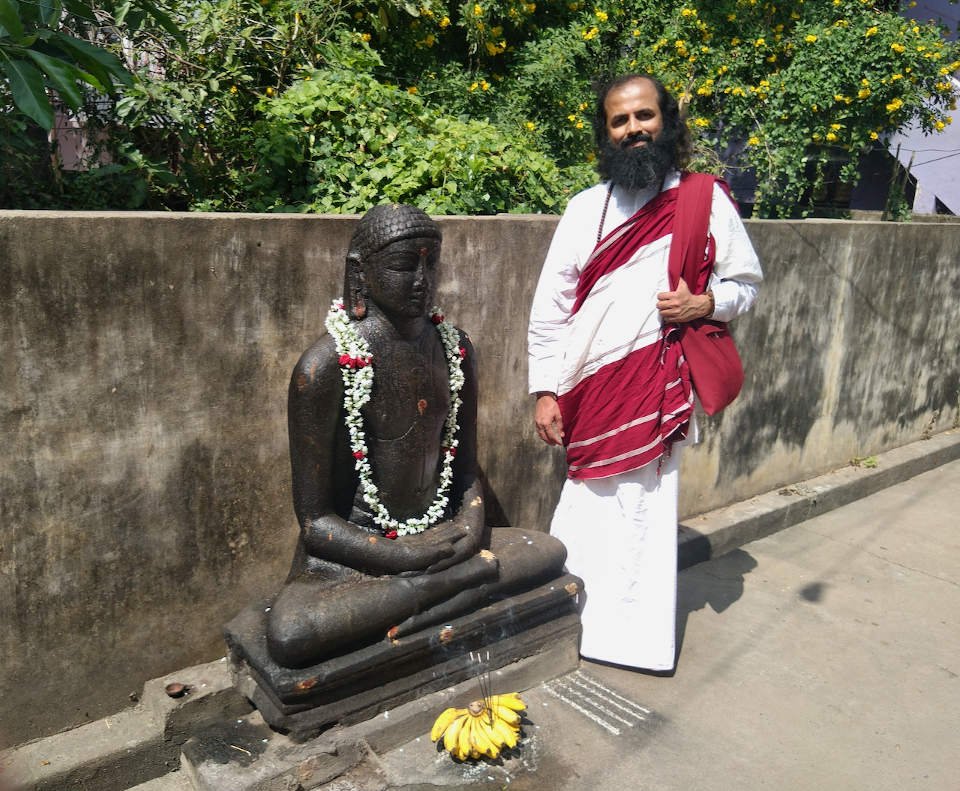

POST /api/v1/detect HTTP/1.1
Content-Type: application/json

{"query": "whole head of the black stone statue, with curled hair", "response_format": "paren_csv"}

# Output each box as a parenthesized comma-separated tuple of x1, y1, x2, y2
(343, 204, 441, 319)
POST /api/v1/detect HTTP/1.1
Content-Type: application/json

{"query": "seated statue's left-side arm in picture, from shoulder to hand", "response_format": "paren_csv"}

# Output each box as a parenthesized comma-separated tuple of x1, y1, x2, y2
(287, 344, 455, 574)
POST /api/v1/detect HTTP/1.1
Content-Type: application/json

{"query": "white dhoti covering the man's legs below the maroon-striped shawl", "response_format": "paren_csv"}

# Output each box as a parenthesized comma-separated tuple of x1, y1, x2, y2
(550, 445, 681, 670)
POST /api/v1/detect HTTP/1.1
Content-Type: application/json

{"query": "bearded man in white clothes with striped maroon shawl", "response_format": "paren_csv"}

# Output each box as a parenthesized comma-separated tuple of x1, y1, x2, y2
(528, 74, 763, 672)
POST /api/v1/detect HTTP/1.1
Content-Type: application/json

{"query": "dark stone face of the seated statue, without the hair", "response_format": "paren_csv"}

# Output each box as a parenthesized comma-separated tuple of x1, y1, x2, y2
(363, 237, 440, 317)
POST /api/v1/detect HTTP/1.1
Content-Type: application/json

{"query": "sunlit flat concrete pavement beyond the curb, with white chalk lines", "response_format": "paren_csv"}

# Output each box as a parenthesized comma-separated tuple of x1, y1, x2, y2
(382, 461, 960, 791)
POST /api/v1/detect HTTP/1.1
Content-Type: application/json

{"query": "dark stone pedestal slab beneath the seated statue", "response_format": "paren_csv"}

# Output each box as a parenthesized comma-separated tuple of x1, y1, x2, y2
(225, 575, 583, 740)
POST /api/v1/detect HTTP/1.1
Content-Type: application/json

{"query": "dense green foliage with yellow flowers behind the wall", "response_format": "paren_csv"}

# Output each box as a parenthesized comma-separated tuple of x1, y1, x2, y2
(0, 0, 960, 216)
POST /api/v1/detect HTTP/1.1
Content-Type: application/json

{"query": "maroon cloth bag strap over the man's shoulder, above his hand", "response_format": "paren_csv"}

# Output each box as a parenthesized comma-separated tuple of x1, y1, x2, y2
(667, 173, 717, 293)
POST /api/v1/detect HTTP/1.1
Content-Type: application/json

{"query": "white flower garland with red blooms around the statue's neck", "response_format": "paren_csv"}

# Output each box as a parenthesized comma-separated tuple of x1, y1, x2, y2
(325, 300, 467, 538)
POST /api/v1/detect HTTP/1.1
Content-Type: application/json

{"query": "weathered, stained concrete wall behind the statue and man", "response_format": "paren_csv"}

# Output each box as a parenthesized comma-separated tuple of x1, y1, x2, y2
(0, 212, 960, 746)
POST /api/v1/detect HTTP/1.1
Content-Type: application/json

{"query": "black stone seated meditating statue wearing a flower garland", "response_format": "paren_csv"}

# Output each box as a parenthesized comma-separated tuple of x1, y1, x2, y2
(266, 205, 566, 668)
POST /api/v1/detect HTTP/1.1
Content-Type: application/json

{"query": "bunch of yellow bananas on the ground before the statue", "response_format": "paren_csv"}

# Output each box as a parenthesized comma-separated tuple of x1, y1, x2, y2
(430, 692, 527, 761)
